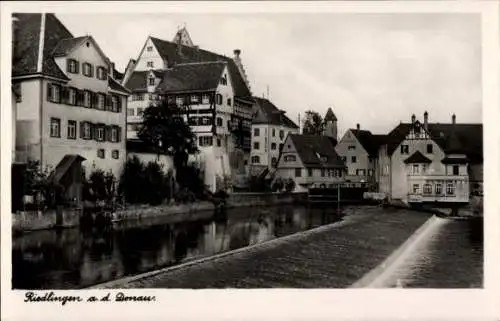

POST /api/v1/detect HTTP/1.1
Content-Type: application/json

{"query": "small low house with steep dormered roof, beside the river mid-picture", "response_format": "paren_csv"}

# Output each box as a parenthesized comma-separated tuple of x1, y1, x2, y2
(276, 134, 346, 191)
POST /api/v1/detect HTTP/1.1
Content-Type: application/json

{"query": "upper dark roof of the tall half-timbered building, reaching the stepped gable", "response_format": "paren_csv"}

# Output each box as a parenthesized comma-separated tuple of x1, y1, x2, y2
(151, 37, 252, 99)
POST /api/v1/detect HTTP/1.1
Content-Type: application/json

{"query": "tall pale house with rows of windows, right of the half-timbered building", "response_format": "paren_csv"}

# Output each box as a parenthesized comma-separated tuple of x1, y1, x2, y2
(250, 97, 299, 174)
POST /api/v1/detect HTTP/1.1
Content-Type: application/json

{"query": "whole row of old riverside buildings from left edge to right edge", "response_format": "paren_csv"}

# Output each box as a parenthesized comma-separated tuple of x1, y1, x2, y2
(12, 14, 482, 205)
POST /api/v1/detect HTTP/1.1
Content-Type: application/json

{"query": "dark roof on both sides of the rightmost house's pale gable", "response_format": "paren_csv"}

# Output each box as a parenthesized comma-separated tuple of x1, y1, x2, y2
(386, 123, 483, 162)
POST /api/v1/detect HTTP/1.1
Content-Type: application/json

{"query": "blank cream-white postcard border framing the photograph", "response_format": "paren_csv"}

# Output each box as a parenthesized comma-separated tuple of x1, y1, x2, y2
(0, 1, 500, 321)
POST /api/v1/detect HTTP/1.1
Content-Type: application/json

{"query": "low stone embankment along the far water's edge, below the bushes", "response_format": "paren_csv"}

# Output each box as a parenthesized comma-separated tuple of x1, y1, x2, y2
(12, 193, 307, 233)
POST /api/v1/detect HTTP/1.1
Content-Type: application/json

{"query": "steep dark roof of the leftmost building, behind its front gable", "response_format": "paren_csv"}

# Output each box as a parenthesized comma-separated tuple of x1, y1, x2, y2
(12, 13, 73, 80)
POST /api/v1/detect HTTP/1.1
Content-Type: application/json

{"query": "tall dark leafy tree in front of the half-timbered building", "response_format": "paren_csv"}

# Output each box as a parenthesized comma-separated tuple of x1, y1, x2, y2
(138, 100, 198, 185)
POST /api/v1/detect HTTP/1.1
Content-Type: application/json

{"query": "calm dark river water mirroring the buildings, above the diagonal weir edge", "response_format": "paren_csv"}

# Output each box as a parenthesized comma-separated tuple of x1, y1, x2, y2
(12, 206, 340, 289)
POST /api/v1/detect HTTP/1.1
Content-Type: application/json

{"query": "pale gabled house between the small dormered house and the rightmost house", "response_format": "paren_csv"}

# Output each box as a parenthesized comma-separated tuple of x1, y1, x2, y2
(335, 124, 385, 190)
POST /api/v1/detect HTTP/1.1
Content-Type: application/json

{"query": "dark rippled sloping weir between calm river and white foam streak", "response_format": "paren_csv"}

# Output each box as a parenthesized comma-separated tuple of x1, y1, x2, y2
(106, 207, 431, 288)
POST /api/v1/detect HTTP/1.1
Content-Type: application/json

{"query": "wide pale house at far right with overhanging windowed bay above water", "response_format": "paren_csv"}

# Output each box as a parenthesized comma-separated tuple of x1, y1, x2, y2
(379, 112, 483, 204)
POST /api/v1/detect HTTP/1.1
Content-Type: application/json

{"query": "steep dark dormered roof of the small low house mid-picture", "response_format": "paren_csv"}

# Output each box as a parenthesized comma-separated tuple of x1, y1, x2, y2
(288, 134, 345, 168)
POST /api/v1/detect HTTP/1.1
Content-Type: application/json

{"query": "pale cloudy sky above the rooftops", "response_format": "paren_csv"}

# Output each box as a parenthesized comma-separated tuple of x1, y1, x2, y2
(57, 13, 482, 135)
